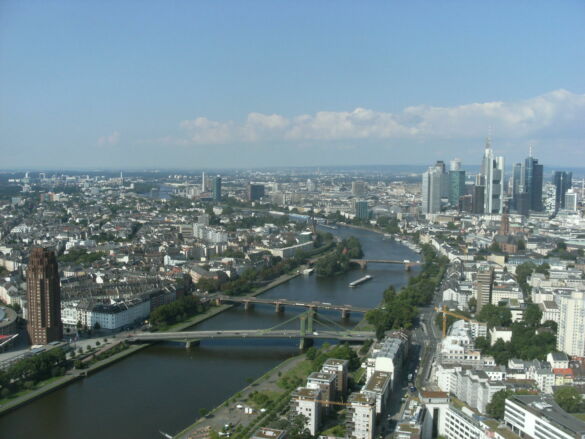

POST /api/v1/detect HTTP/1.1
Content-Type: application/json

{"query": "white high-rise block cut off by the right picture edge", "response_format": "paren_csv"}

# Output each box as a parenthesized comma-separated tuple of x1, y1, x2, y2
(557, 291, 585, 357)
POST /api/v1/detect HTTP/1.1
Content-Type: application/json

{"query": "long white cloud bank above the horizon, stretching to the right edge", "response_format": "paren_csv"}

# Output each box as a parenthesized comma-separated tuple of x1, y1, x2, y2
(173, 90, 585, 145)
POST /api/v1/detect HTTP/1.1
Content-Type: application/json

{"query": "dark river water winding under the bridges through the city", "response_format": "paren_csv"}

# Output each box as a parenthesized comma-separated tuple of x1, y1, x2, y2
(0, 227, 419, 439)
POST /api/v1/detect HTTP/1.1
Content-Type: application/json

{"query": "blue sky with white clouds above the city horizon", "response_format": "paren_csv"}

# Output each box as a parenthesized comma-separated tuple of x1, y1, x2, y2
(0, 0, 585, 169)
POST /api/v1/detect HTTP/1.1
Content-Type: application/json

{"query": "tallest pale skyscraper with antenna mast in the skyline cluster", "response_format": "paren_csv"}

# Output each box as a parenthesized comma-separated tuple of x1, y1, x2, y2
(481, 137, 504, 214)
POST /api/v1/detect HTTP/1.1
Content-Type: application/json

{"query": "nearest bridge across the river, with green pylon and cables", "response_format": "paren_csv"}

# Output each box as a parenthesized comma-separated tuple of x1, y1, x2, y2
(131, 309, 376, 349)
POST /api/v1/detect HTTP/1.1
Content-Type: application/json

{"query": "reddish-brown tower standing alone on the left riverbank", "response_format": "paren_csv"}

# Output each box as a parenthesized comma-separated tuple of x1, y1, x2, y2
(26, 247, 63, 345)
